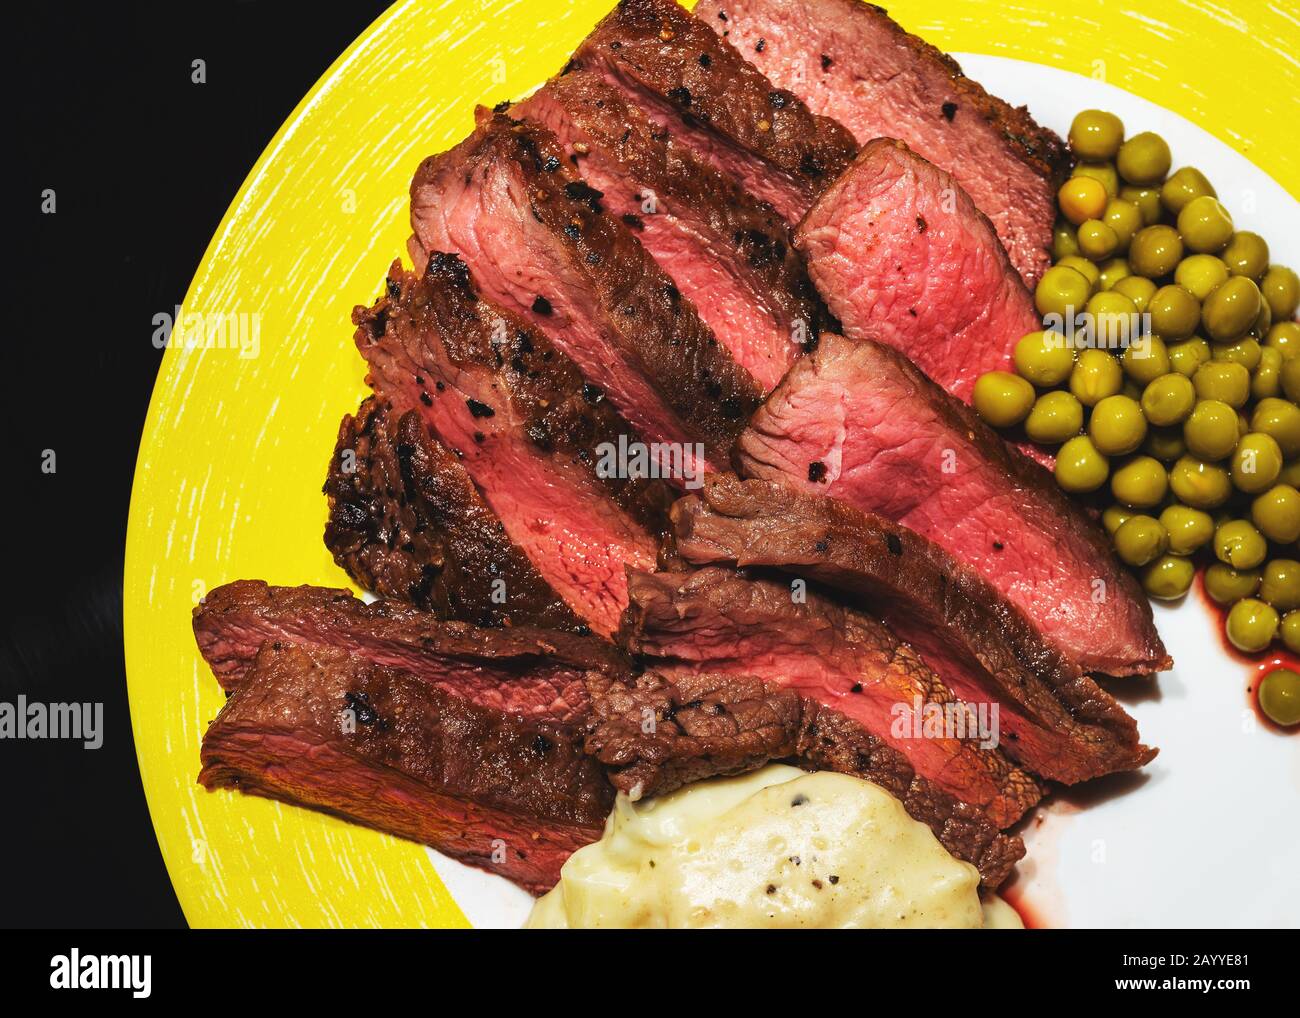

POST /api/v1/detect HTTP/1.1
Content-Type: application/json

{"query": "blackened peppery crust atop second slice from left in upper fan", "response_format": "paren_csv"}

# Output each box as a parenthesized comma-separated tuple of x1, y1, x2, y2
(352, 252, 673, 536)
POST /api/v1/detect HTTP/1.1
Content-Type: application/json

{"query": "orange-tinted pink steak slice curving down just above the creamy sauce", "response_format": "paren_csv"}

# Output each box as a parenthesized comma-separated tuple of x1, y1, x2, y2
(620, 568, 1043, 827)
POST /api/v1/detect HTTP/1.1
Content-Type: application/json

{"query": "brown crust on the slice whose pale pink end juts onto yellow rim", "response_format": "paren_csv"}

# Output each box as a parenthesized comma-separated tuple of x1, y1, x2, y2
(408, 114, 762, 463)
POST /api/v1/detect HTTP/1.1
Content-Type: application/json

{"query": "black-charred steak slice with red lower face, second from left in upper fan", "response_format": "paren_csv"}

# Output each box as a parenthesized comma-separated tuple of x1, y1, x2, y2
(354, 254, 672, 634)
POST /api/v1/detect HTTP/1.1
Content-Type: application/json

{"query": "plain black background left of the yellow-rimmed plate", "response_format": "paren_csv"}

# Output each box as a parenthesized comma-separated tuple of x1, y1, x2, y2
(0, 0, 386, 928)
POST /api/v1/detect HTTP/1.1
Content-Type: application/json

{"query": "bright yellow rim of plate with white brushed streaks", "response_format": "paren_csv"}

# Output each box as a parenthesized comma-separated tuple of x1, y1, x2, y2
(124, 0, 1300, 927)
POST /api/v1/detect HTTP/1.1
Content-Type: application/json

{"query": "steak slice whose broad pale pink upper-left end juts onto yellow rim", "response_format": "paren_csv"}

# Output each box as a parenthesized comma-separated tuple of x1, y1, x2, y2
(411, 114, 762, 476)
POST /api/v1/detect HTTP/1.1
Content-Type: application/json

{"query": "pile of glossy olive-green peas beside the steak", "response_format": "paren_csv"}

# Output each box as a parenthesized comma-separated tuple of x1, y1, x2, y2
(972, 109, 1300, 725)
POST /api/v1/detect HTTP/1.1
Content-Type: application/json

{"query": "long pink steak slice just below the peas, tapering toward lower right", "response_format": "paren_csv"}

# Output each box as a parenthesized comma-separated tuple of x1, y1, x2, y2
(737, 334, 1171, 675)
